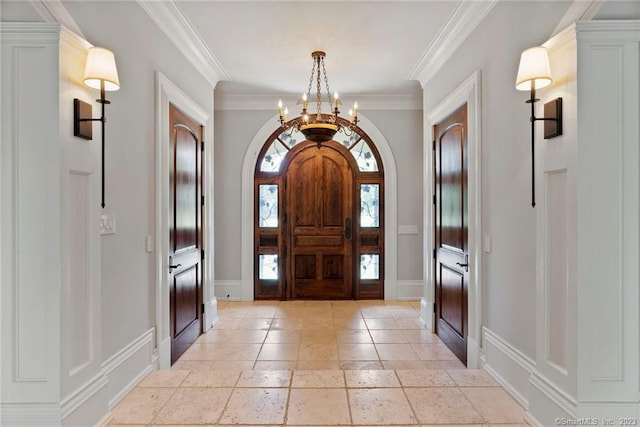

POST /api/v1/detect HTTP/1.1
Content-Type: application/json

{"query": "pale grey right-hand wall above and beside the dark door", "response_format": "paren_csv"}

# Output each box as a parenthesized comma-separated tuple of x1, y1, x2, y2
(424, 2, 567, 358)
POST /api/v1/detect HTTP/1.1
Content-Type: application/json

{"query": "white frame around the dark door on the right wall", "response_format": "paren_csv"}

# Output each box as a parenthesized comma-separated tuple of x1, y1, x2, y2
(421, 70, 482, 368)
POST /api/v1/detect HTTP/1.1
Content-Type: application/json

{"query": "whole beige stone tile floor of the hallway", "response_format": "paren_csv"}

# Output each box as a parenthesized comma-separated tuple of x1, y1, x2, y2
(109, 301, 526, 426)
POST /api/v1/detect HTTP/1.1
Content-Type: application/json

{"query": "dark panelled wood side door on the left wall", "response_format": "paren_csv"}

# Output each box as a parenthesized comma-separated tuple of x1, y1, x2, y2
(169, 105, 203, 364)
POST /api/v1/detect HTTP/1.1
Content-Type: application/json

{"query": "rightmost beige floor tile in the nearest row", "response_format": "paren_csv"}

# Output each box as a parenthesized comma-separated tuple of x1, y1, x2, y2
(460, 387, 524, 423)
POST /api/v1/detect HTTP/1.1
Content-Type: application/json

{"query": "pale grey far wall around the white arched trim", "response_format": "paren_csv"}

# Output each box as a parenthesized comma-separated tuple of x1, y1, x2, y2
(214, 108, 422, 290)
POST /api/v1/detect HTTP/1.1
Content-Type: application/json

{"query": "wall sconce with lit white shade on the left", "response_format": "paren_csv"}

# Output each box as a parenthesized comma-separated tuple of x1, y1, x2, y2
(73, 47, 120, 209)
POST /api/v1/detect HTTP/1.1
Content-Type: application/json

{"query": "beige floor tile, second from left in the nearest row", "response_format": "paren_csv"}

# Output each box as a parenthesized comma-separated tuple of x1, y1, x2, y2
(153, 388, 231, 424)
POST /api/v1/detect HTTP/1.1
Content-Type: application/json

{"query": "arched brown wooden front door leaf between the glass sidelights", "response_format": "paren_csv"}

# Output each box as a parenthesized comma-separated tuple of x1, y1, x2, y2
(285, 145, 353, 299)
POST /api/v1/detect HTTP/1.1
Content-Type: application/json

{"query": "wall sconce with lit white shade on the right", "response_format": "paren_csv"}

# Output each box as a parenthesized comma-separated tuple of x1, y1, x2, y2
(516, 47, 562, 207)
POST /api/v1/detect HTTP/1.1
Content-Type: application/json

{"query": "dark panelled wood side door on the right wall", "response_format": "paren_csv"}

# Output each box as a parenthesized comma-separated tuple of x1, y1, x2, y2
(433, 105, 469, 365)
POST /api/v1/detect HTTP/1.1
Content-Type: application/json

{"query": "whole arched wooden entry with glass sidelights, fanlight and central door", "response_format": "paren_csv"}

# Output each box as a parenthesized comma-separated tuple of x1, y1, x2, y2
(253, 116, 385, 299)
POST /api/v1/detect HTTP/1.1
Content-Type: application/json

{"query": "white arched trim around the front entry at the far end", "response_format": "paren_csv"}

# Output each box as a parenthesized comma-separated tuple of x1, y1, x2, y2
(241, 115, 398, 301)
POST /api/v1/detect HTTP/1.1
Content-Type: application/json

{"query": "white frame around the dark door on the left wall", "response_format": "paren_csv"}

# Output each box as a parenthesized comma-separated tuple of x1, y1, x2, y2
(152, 71, 218, 369)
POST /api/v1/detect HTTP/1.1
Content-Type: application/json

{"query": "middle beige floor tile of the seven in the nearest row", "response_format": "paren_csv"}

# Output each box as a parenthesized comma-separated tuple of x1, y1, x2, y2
(287, 388, 351, 425)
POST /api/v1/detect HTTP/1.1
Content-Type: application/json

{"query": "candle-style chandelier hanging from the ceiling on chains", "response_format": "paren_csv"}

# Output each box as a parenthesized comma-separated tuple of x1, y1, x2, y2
(278, 50, 358, 146)
